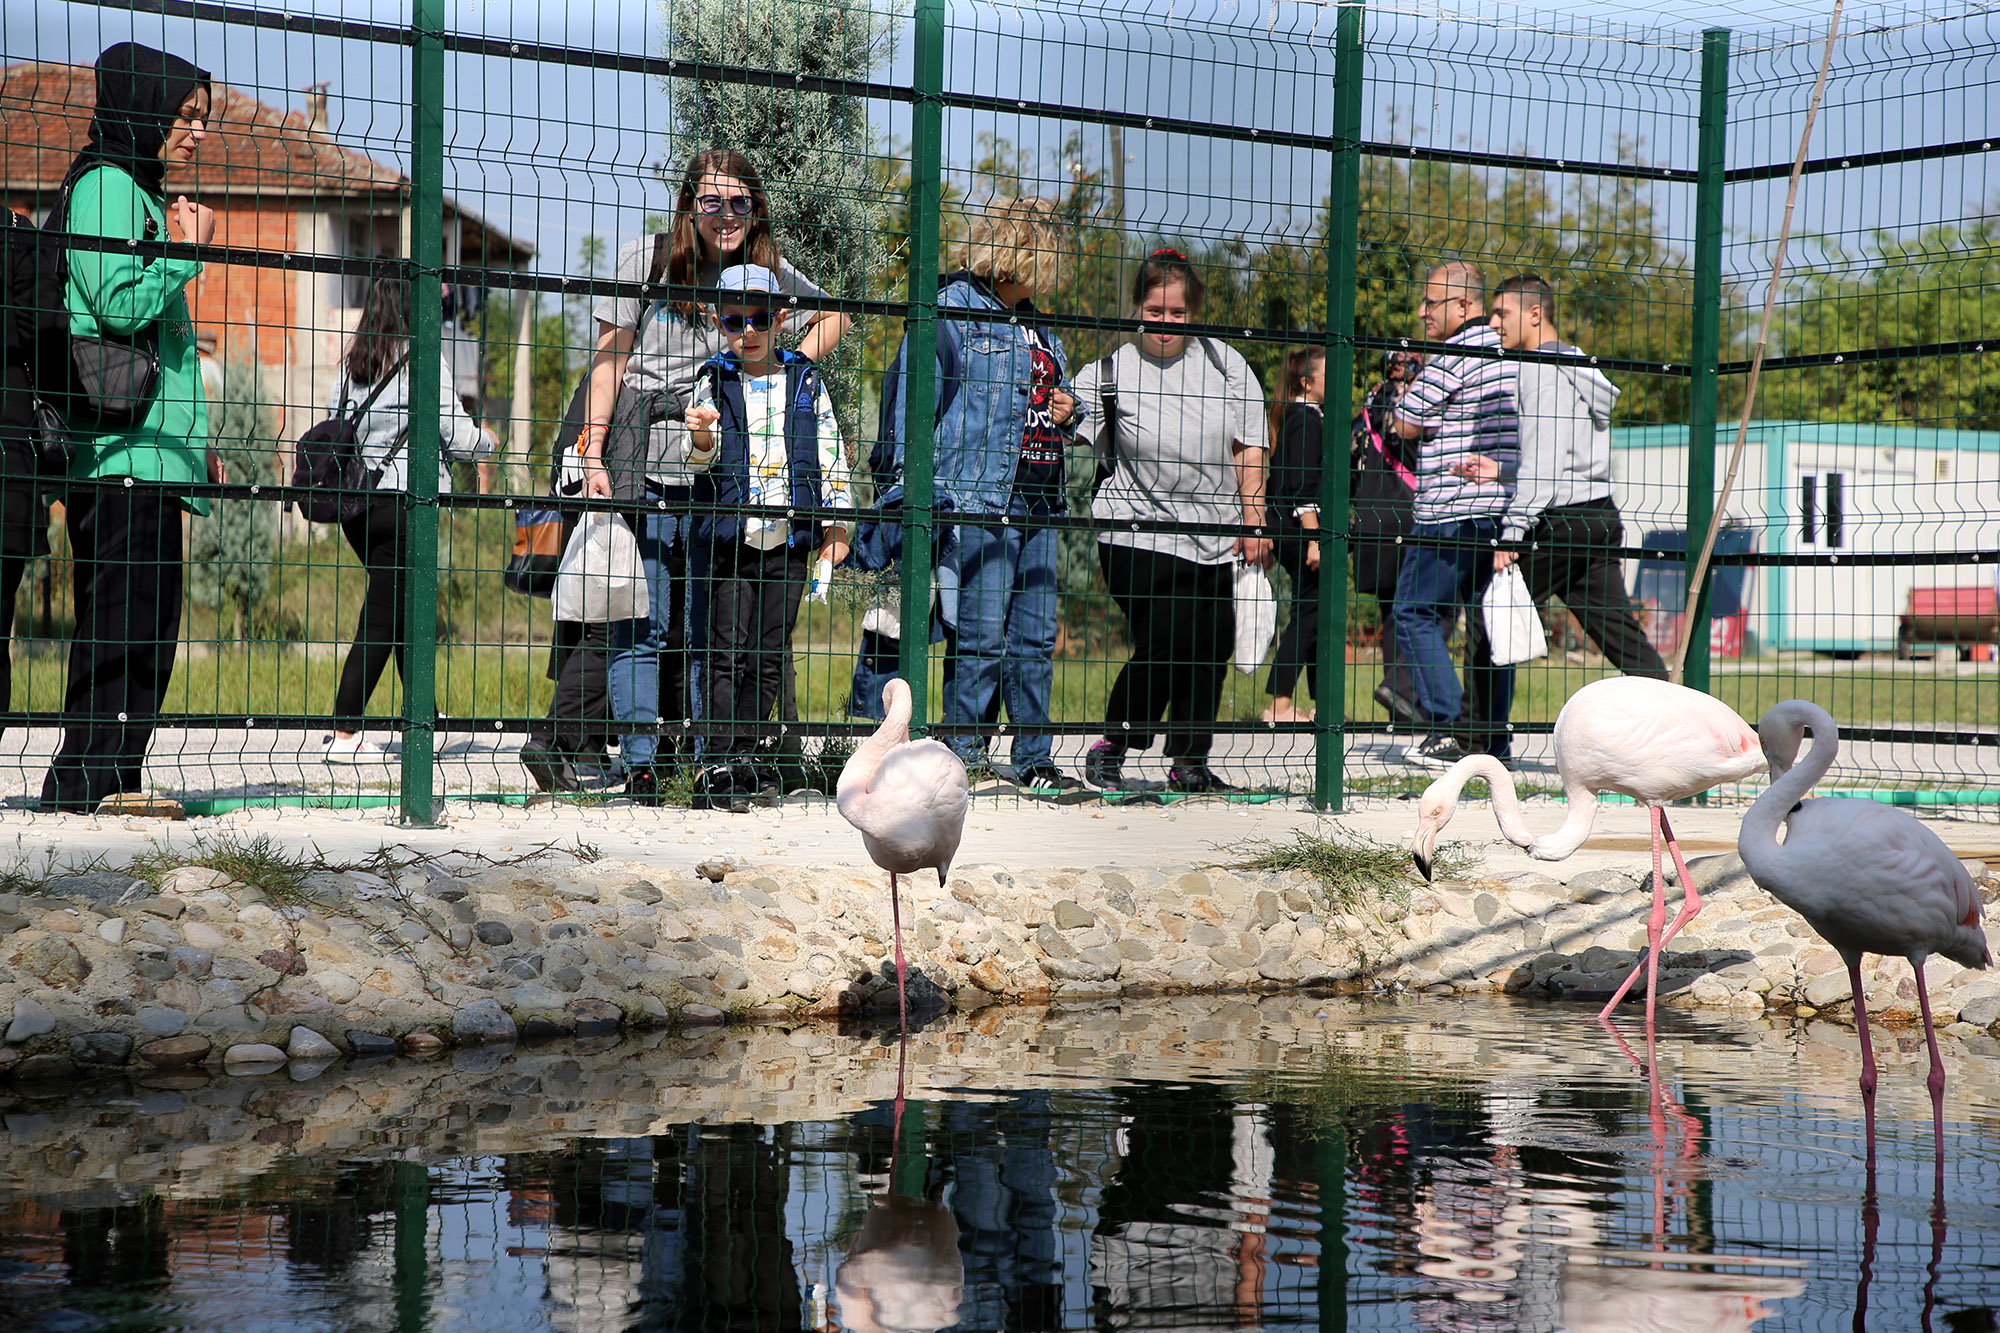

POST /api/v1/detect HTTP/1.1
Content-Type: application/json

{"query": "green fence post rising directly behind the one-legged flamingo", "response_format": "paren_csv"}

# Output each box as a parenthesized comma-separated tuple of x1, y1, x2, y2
(900, 0, 944, 729)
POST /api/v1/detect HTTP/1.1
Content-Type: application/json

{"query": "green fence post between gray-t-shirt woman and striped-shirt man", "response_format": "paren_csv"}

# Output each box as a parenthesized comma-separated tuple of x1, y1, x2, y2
(1320, 4, 1362, 815)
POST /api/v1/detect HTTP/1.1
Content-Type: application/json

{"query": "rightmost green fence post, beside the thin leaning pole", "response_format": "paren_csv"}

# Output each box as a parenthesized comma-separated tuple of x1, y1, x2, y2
(1680, 28, 1730, 691)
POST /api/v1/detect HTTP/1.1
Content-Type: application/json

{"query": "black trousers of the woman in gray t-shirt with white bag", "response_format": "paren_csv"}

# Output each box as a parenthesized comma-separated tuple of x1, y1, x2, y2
(1098, 542, 1236, 763)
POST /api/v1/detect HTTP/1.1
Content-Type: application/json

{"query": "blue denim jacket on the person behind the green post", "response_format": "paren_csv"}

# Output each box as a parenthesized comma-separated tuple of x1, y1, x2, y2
(874, 272, 1074, 514)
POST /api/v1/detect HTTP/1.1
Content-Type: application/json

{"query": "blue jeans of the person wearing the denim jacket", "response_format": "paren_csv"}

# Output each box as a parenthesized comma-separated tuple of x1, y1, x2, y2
(944, 496, 1056, 771)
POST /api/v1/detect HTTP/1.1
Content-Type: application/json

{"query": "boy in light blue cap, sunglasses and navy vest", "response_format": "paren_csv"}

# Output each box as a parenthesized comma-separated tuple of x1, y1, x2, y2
(686, 264, 854, 813)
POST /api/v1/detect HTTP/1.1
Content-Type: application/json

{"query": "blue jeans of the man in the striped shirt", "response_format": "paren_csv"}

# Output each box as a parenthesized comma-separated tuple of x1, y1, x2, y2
(1396, 518, 1514, 755)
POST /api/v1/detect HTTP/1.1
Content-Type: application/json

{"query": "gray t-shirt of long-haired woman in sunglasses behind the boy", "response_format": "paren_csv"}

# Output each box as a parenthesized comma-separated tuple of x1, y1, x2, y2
(592, 236, 826, 486)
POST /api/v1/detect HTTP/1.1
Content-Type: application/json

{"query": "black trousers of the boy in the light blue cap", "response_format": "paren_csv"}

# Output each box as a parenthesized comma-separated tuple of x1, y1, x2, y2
(706, 540, 812, 759)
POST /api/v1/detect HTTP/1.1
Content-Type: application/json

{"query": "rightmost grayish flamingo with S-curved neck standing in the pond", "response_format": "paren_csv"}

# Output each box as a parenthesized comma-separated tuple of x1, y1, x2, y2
(1736, 699, 1994, 1163)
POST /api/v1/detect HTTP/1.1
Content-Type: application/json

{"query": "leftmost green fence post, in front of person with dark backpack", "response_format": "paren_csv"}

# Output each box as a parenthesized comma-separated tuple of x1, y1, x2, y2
(402, 0, 444, 825)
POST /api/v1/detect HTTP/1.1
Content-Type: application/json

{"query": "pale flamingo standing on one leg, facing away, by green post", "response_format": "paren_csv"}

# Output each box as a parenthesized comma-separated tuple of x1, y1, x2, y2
(834, 677, 972, 1027)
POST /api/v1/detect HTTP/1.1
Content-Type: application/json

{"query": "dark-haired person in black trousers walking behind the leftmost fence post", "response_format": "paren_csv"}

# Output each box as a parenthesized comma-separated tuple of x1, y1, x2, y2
(320, 278, 494, 765)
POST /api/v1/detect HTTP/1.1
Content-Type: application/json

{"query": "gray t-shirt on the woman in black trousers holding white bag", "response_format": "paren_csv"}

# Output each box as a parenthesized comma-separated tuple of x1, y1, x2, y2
(1076, 338, 1268, 564)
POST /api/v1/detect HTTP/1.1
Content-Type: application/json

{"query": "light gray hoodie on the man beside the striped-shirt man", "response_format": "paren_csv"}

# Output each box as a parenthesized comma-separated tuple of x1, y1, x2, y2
(1500, 338, 1618, 540)
